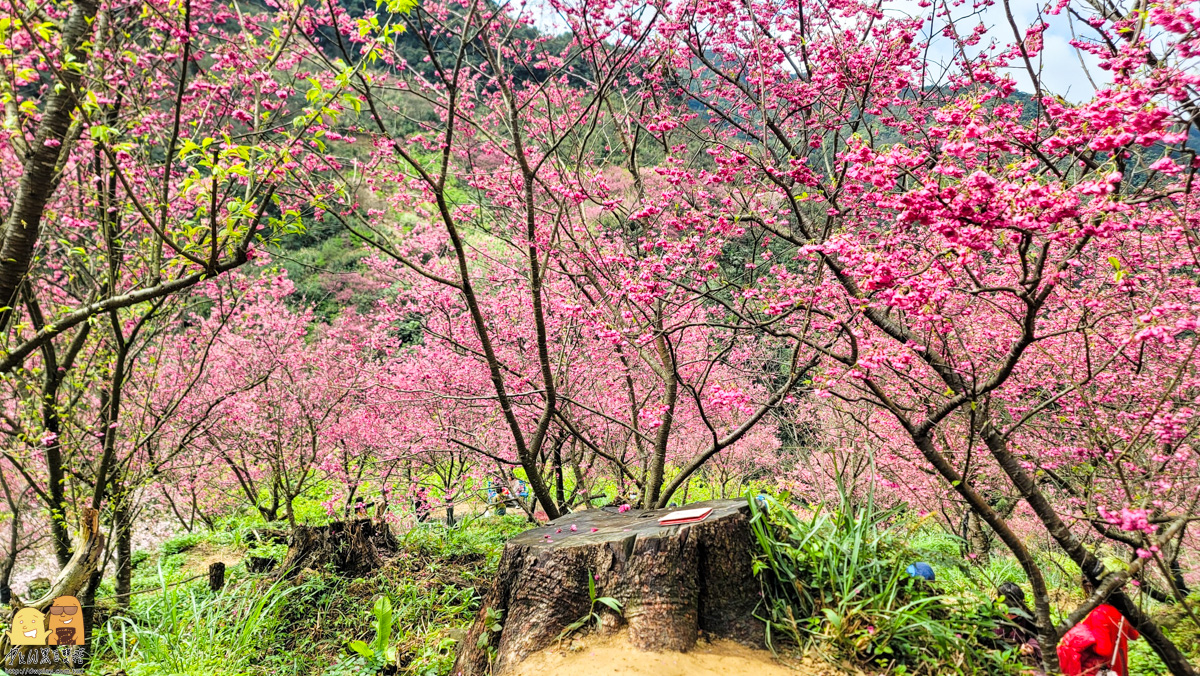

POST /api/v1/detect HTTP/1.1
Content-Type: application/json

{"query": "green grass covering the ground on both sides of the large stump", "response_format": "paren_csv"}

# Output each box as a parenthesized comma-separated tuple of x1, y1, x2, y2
(89, 485, 1200, 676)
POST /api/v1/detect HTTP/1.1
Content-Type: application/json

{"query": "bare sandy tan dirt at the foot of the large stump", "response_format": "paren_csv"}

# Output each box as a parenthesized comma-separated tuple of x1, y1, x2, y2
(506, 635, 847, 676)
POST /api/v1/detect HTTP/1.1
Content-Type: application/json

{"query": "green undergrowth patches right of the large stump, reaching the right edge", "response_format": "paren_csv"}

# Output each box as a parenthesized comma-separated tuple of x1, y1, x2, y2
(751, 493, 1200, 676)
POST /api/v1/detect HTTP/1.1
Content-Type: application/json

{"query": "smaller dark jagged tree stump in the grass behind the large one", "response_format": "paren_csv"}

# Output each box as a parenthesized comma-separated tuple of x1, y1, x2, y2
(280, 519, 400, 578)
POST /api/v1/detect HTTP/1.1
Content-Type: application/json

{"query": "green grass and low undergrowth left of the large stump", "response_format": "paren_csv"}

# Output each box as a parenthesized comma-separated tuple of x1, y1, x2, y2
(89, 516, 528, 676)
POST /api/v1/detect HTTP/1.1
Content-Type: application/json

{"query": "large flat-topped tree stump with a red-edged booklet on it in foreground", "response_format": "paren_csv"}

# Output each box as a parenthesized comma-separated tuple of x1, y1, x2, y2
(452, 499, 763, 676)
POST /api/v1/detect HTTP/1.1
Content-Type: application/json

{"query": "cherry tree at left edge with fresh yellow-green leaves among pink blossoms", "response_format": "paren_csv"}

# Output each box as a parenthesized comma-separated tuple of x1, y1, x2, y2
(0, 0, 384, 612)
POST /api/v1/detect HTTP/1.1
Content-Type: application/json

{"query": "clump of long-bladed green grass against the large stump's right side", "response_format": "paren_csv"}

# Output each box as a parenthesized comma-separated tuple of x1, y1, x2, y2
(750, 491, 1020, 675)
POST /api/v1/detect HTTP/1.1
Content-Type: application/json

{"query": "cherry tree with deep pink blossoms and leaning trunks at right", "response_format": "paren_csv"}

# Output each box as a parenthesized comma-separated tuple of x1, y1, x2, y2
(619, 2, 1196, 674)
